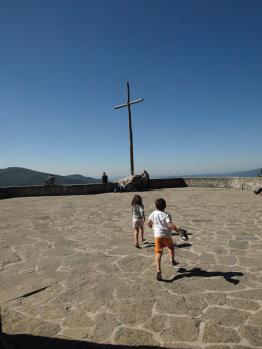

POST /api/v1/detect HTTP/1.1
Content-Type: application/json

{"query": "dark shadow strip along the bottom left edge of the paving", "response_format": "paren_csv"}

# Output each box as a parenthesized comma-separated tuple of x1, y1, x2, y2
(0, 333, 176, 349)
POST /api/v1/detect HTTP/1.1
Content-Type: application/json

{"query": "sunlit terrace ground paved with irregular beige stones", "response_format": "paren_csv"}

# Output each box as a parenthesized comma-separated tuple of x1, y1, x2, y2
(0, 188, 262, 349)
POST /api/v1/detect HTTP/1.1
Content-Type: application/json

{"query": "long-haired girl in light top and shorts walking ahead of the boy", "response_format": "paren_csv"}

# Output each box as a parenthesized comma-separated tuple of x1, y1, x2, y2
(131, 195, 145, 248)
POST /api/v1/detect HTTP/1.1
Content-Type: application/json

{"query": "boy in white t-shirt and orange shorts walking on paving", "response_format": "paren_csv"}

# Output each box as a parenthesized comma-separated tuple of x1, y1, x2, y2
(147, 198, 179, 281)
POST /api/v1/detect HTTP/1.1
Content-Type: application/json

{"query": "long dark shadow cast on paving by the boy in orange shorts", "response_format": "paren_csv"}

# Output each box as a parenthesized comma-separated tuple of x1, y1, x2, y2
(163, 268, 244, 285)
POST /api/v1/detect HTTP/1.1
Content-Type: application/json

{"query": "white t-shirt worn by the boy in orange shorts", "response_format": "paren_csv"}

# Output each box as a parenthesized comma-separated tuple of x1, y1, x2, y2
(148, 210, 172, 238)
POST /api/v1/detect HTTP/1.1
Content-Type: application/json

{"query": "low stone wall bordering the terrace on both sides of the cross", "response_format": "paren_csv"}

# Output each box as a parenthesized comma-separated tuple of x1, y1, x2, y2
(0, 177, 262, 199)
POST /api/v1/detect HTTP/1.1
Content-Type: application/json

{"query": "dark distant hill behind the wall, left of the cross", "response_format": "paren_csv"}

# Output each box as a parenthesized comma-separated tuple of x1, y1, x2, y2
(0, 167, 100, 187)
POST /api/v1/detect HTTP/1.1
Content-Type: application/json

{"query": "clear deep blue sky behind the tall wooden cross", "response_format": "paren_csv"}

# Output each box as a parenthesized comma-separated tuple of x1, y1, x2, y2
(0, 0, 262, 177)
